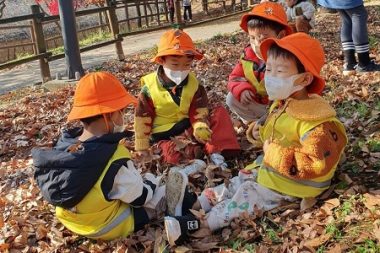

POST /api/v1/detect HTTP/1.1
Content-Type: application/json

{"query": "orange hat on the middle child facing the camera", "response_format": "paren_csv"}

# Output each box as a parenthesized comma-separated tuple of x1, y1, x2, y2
(152, 29, 203, 64)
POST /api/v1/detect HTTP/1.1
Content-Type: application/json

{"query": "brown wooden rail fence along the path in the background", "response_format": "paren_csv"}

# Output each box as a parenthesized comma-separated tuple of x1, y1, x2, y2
(0, 0, 247, 82)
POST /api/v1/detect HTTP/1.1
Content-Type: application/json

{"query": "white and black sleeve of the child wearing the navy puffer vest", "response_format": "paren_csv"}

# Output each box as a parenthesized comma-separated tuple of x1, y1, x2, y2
(107, 160, 158, 207)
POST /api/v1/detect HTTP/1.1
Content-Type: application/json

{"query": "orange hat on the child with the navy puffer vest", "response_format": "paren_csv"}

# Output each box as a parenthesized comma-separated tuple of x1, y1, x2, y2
(68, 72, 137, 121)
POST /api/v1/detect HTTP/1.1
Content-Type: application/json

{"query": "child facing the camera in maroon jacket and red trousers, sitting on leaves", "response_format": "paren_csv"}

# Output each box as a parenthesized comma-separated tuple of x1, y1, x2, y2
(135, 30, 239, 167)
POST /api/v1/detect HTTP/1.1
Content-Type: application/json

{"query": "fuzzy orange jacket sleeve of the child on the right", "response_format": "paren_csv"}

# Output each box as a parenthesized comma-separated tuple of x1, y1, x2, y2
(264, 122, 347, 179)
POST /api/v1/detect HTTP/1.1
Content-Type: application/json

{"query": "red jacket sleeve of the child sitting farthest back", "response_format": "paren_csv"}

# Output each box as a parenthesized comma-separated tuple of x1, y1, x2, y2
(227, 60, 256, 101)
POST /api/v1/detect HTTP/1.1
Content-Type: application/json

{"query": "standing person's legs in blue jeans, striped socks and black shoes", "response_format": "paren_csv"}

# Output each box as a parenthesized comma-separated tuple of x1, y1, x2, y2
(318, 0, 380, 75)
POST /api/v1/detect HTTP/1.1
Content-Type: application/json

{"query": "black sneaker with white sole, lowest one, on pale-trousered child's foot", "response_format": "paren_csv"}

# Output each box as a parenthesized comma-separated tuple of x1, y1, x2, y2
(164, 215, 200, 246)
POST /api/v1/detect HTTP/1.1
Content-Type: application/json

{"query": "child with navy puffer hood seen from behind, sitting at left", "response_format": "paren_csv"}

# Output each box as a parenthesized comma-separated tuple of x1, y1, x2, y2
(32, 72, 194, 240)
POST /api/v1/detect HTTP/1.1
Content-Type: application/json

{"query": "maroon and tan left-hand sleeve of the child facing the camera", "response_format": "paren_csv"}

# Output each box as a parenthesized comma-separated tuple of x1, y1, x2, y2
(134, 86, 156, 151)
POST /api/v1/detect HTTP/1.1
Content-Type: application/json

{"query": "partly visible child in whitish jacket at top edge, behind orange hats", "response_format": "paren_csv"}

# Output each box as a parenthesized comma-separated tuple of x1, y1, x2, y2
(286, 0, 315, 33)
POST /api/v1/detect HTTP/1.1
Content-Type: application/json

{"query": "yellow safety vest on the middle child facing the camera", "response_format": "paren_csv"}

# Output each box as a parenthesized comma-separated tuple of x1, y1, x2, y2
(141, 72, 199, 133)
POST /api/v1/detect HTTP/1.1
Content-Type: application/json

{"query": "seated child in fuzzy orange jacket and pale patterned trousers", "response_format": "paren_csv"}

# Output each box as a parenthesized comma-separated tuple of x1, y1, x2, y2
(165, 33, 347, 244)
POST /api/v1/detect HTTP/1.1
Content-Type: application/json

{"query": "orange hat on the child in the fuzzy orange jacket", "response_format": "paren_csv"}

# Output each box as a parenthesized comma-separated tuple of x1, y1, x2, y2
(260, 33, 325, 94)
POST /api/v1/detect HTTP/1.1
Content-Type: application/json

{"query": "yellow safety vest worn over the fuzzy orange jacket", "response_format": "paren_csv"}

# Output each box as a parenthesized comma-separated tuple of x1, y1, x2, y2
(255, 98, 346, 198)
